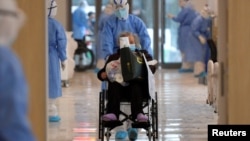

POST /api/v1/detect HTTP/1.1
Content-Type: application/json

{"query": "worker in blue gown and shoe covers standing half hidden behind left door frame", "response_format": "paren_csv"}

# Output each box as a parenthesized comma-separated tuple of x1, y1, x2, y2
(47, 0, 67, 122)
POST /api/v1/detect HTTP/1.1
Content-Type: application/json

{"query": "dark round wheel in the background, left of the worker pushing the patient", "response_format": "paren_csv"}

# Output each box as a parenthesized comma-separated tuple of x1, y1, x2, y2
(74, 48, 95, 71)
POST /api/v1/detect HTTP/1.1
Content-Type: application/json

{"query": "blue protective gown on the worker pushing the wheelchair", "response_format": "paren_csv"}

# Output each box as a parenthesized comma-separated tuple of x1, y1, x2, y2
(101, 14, 153, 57)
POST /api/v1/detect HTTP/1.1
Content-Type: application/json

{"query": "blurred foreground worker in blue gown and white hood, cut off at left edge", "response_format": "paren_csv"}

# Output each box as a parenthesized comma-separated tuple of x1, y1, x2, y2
(0, 0, 36, 141)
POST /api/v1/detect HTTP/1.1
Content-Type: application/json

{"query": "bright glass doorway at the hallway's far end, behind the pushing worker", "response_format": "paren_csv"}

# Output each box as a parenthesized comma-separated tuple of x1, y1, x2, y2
(71, 0, 181, 68)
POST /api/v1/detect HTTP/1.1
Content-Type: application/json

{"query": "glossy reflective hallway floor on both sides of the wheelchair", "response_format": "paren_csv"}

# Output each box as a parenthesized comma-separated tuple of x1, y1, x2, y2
(48, 69, 217, 141)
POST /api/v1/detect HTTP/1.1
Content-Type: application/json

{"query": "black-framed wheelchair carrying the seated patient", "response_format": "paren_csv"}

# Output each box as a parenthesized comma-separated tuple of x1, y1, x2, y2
(98, 82, 158, 141)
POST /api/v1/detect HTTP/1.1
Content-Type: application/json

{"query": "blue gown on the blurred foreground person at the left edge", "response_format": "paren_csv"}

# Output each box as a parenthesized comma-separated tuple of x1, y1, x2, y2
(0, 47, 35, 141)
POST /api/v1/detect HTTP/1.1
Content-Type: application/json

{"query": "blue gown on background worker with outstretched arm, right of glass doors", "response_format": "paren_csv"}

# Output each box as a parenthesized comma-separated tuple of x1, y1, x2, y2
(173, 5, 197, 54)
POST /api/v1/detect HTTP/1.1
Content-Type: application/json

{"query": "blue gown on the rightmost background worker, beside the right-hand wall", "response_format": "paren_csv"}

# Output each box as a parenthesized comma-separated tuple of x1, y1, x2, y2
(185, 15, 211, 64)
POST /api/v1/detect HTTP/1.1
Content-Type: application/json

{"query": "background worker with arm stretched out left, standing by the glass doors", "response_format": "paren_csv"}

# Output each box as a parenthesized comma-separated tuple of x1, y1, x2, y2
(168, 0, 198, 73)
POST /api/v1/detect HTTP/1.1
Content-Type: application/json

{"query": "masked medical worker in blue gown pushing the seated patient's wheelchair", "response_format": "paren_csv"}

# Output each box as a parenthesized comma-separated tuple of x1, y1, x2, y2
(100, 0, 153, 140)
